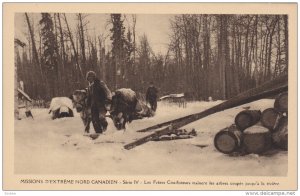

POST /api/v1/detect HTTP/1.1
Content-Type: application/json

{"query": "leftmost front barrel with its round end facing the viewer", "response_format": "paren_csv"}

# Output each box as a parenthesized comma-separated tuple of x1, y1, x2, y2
(214, 125, 242, 154)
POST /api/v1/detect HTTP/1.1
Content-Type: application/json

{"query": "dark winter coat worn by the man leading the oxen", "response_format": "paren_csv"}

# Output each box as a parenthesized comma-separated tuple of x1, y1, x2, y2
(87, 79, 111, 108)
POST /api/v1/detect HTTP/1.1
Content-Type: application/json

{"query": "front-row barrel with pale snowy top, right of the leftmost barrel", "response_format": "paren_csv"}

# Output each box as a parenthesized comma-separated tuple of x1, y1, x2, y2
(243, 125, 272, 154)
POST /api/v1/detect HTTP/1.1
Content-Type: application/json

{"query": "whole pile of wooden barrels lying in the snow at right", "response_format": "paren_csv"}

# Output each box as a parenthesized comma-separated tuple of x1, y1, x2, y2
(214, 92, 288, 154)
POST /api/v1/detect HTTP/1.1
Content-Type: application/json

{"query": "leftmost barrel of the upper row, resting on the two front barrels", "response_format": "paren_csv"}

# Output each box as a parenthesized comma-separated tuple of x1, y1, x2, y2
(234, 110, 261, 131)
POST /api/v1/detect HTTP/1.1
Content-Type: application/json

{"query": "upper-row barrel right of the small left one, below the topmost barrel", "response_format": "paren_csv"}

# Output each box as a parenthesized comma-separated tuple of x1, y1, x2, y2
(260, 108, 283, 132)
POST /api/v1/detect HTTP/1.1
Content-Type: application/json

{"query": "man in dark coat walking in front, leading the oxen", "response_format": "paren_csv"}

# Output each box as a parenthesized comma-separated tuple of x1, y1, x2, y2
(86, 71, 111, 133)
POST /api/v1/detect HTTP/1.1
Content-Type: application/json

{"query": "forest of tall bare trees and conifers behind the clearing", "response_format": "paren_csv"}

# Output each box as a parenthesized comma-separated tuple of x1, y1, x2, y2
(14, 13, 288, 101)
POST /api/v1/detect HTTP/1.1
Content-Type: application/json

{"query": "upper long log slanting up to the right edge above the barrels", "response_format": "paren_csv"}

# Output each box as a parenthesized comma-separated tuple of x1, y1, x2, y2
(138, 75, 288, 132)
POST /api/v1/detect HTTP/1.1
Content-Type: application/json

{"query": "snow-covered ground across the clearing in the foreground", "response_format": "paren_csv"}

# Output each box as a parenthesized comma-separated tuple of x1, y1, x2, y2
(15, 99, 288, 176)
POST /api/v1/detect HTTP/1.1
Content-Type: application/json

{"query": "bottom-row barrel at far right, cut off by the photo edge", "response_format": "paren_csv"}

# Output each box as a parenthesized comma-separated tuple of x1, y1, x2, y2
(272, 117, 288, 150)
